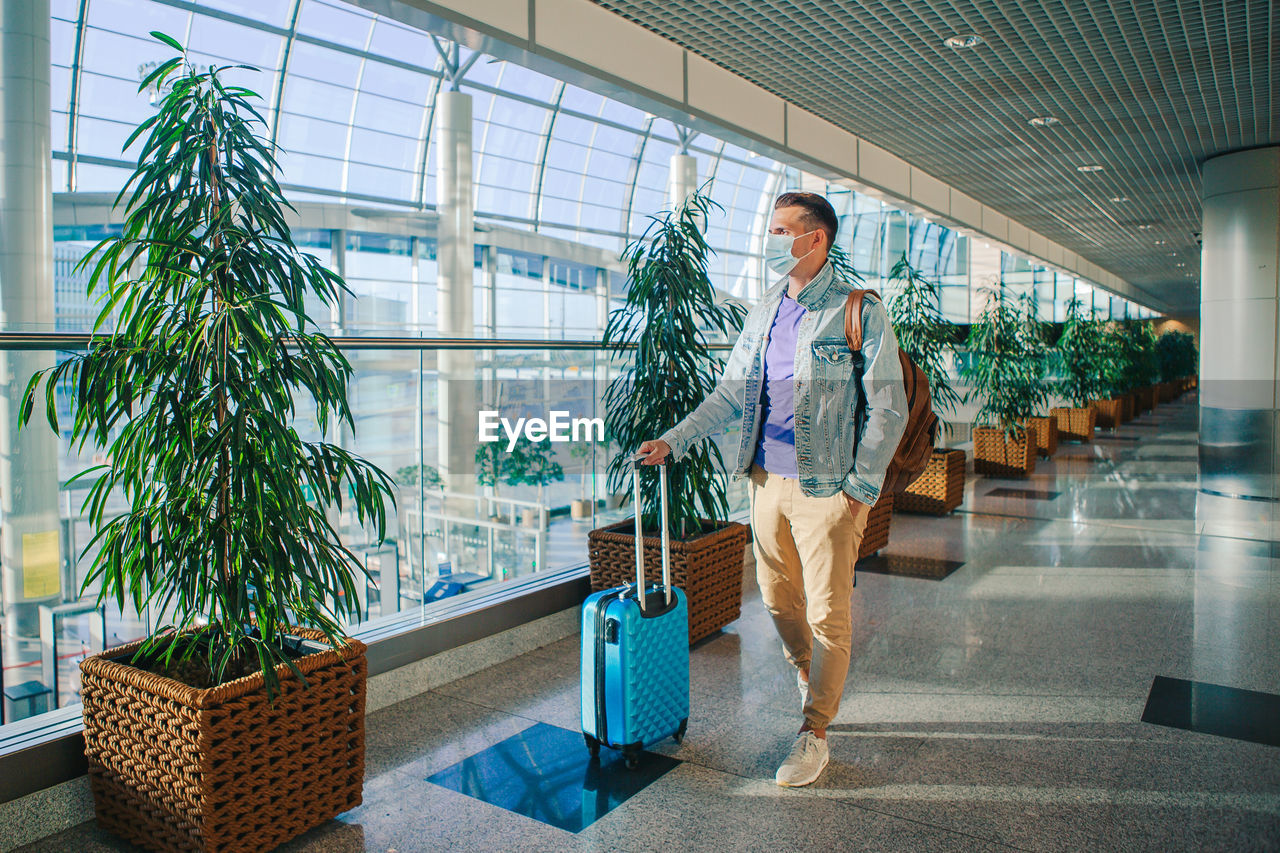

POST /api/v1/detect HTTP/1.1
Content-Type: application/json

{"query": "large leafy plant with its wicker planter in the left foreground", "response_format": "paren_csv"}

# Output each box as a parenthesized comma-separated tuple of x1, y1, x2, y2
(22, 33, 394, 850)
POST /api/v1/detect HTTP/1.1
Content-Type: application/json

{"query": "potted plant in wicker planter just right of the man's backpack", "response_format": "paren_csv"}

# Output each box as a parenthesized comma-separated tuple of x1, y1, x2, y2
(888, 252, 965, 515)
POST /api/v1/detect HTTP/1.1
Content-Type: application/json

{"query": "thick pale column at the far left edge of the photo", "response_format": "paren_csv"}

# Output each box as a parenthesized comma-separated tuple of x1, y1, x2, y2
(0, 0, 61, 637)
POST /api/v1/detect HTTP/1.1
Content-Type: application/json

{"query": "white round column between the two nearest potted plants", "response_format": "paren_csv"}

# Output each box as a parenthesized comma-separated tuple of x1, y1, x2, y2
(435, 91, 476, 492)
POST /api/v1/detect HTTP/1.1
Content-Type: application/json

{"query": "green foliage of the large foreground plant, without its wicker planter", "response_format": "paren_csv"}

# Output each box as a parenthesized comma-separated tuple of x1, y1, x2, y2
(31, 44, 394, 690)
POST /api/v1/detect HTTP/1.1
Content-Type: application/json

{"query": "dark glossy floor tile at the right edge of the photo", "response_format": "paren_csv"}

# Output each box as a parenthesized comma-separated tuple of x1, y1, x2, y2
(1142, 675, 1280, 747)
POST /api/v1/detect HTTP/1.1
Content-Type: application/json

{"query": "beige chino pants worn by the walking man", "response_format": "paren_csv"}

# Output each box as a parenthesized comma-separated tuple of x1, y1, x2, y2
(750, 465, 870, 729)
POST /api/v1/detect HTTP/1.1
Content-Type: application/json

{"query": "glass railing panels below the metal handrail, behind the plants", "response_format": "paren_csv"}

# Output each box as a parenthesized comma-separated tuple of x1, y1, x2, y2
(0, 334, 746, 724)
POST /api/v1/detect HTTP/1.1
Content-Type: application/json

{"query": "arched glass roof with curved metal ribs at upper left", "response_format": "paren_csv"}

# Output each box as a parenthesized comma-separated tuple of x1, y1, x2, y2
(52, 0, 783, 295)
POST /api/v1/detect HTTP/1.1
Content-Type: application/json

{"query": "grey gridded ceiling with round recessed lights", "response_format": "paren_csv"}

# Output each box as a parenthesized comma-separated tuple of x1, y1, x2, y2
(594, 0, 1280, 307)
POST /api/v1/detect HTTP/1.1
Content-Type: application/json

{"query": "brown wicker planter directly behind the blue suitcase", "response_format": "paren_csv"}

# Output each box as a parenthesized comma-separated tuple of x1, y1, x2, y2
(586, 519, 751, 643)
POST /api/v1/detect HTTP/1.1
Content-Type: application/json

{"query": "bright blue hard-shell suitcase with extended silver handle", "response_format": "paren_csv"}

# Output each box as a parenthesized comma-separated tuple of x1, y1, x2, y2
(582, 461, 689, 767)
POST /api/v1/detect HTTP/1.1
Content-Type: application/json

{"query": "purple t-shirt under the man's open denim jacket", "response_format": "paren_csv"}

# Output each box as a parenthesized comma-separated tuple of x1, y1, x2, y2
(755, 293, 805, 479)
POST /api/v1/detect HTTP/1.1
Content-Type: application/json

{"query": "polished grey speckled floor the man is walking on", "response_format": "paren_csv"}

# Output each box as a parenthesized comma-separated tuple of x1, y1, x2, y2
(17, 397, 1280, 853)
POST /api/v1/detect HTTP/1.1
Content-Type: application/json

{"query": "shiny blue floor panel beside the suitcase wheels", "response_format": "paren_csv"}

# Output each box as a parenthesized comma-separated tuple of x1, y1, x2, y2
(426, 722, 680, 833)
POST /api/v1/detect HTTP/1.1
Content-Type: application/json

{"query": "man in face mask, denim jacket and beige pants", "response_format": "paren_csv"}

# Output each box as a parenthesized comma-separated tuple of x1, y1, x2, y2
(640, 192, 908, 786)
